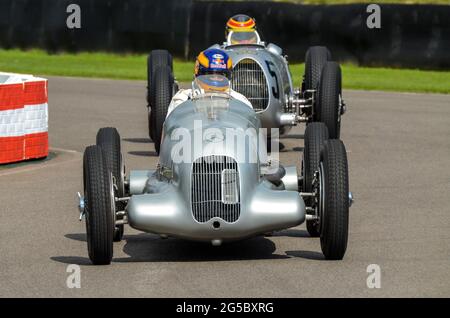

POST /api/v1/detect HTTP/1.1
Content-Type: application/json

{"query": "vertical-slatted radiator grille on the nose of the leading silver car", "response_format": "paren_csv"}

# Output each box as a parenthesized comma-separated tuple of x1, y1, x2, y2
(191, 155, 241, 222)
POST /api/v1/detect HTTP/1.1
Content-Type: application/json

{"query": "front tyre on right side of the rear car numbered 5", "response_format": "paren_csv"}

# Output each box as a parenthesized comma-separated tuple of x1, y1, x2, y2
(314, 62, 342, 139)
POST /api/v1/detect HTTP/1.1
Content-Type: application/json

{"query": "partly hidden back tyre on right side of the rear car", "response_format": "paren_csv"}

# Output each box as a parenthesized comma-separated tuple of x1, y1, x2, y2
(305, 46, 331, 89)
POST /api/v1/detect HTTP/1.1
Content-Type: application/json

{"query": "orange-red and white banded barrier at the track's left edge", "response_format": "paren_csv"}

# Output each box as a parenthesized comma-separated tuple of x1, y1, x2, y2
(0, 72, 48, 163)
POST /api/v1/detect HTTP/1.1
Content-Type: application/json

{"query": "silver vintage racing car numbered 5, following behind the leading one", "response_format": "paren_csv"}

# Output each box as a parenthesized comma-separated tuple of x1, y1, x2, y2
(147, 30, 346, 144)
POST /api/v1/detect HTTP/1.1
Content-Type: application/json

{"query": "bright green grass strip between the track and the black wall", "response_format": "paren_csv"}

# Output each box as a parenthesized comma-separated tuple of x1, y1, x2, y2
(0, 50, 450, 94)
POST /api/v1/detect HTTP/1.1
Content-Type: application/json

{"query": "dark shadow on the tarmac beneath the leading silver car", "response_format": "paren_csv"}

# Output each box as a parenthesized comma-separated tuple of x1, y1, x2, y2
(51, 229, 324, 265)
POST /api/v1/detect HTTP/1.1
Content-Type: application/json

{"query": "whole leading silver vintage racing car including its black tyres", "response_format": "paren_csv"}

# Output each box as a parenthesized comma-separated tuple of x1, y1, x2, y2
(79, 74, 351, 264)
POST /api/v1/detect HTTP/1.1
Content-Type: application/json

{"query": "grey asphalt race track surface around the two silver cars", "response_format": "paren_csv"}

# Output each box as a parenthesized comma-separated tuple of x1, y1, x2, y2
(0, 78, 450, 297)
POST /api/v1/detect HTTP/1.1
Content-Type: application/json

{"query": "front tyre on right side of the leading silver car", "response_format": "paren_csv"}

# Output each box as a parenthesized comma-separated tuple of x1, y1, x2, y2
(320, 139, 349, 260)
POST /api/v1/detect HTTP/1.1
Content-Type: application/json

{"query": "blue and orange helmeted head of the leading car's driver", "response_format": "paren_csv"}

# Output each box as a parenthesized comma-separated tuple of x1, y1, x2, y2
(194, 49, 233, 79)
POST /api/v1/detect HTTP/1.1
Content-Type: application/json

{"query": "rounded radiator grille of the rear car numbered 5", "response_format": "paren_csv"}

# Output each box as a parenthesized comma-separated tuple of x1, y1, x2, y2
(231, 59, 269, 111)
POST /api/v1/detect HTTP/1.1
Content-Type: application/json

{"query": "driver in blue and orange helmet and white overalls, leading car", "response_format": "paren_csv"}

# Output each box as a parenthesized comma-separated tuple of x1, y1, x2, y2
(167, 49, 253, 116)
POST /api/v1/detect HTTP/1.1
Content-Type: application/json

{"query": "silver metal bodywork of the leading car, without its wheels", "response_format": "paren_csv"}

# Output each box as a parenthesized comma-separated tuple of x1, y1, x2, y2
(127, 96, 305, 245)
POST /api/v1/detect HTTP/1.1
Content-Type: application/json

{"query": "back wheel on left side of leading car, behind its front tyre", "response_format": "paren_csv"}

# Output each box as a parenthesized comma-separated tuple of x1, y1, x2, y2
(96, 127, 125, 242)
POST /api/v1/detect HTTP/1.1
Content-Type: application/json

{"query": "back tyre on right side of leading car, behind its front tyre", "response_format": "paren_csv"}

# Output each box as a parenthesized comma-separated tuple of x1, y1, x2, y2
(303, 123, 328, 237)
